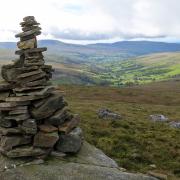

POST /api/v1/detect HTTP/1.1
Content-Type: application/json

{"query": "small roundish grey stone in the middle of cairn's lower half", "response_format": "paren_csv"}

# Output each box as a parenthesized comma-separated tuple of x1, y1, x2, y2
(20, 119, 37, 134)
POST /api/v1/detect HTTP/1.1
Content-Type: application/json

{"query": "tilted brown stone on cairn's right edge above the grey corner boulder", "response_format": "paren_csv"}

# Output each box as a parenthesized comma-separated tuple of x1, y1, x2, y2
(59, 115, 80, 134)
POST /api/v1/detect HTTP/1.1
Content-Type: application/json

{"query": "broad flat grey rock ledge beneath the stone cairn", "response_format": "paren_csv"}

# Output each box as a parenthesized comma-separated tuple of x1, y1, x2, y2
(0, 142, 156, 180)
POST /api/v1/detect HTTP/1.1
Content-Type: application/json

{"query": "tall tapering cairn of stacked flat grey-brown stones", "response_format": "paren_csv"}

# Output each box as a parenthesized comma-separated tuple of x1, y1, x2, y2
(0, 16, 82, 158)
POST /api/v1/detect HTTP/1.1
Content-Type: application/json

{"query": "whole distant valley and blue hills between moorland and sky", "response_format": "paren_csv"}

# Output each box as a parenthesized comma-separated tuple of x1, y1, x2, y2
(0, 40, 180, 86)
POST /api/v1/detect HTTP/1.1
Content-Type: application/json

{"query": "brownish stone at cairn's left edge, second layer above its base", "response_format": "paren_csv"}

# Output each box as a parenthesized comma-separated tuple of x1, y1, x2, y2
(1, 136, 32, 151)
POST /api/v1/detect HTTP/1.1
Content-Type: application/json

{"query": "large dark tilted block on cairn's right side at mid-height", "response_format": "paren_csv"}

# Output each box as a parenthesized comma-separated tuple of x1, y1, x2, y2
(30, 94, 66, 119)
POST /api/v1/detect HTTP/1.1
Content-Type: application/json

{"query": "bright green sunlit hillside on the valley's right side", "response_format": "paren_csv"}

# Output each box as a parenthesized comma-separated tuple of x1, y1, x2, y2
(101, 52, 180, 85)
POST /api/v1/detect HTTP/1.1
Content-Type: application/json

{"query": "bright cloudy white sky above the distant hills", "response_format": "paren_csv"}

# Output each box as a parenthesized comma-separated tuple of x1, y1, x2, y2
(0, 0, 180, 44)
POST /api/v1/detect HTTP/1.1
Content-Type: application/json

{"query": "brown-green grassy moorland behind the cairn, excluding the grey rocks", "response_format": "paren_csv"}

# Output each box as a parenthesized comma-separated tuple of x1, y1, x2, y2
(60, 81, 180, 179)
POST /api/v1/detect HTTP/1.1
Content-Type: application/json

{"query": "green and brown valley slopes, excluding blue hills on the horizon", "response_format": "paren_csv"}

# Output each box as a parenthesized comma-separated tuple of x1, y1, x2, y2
(0, 49, 180, 86)
